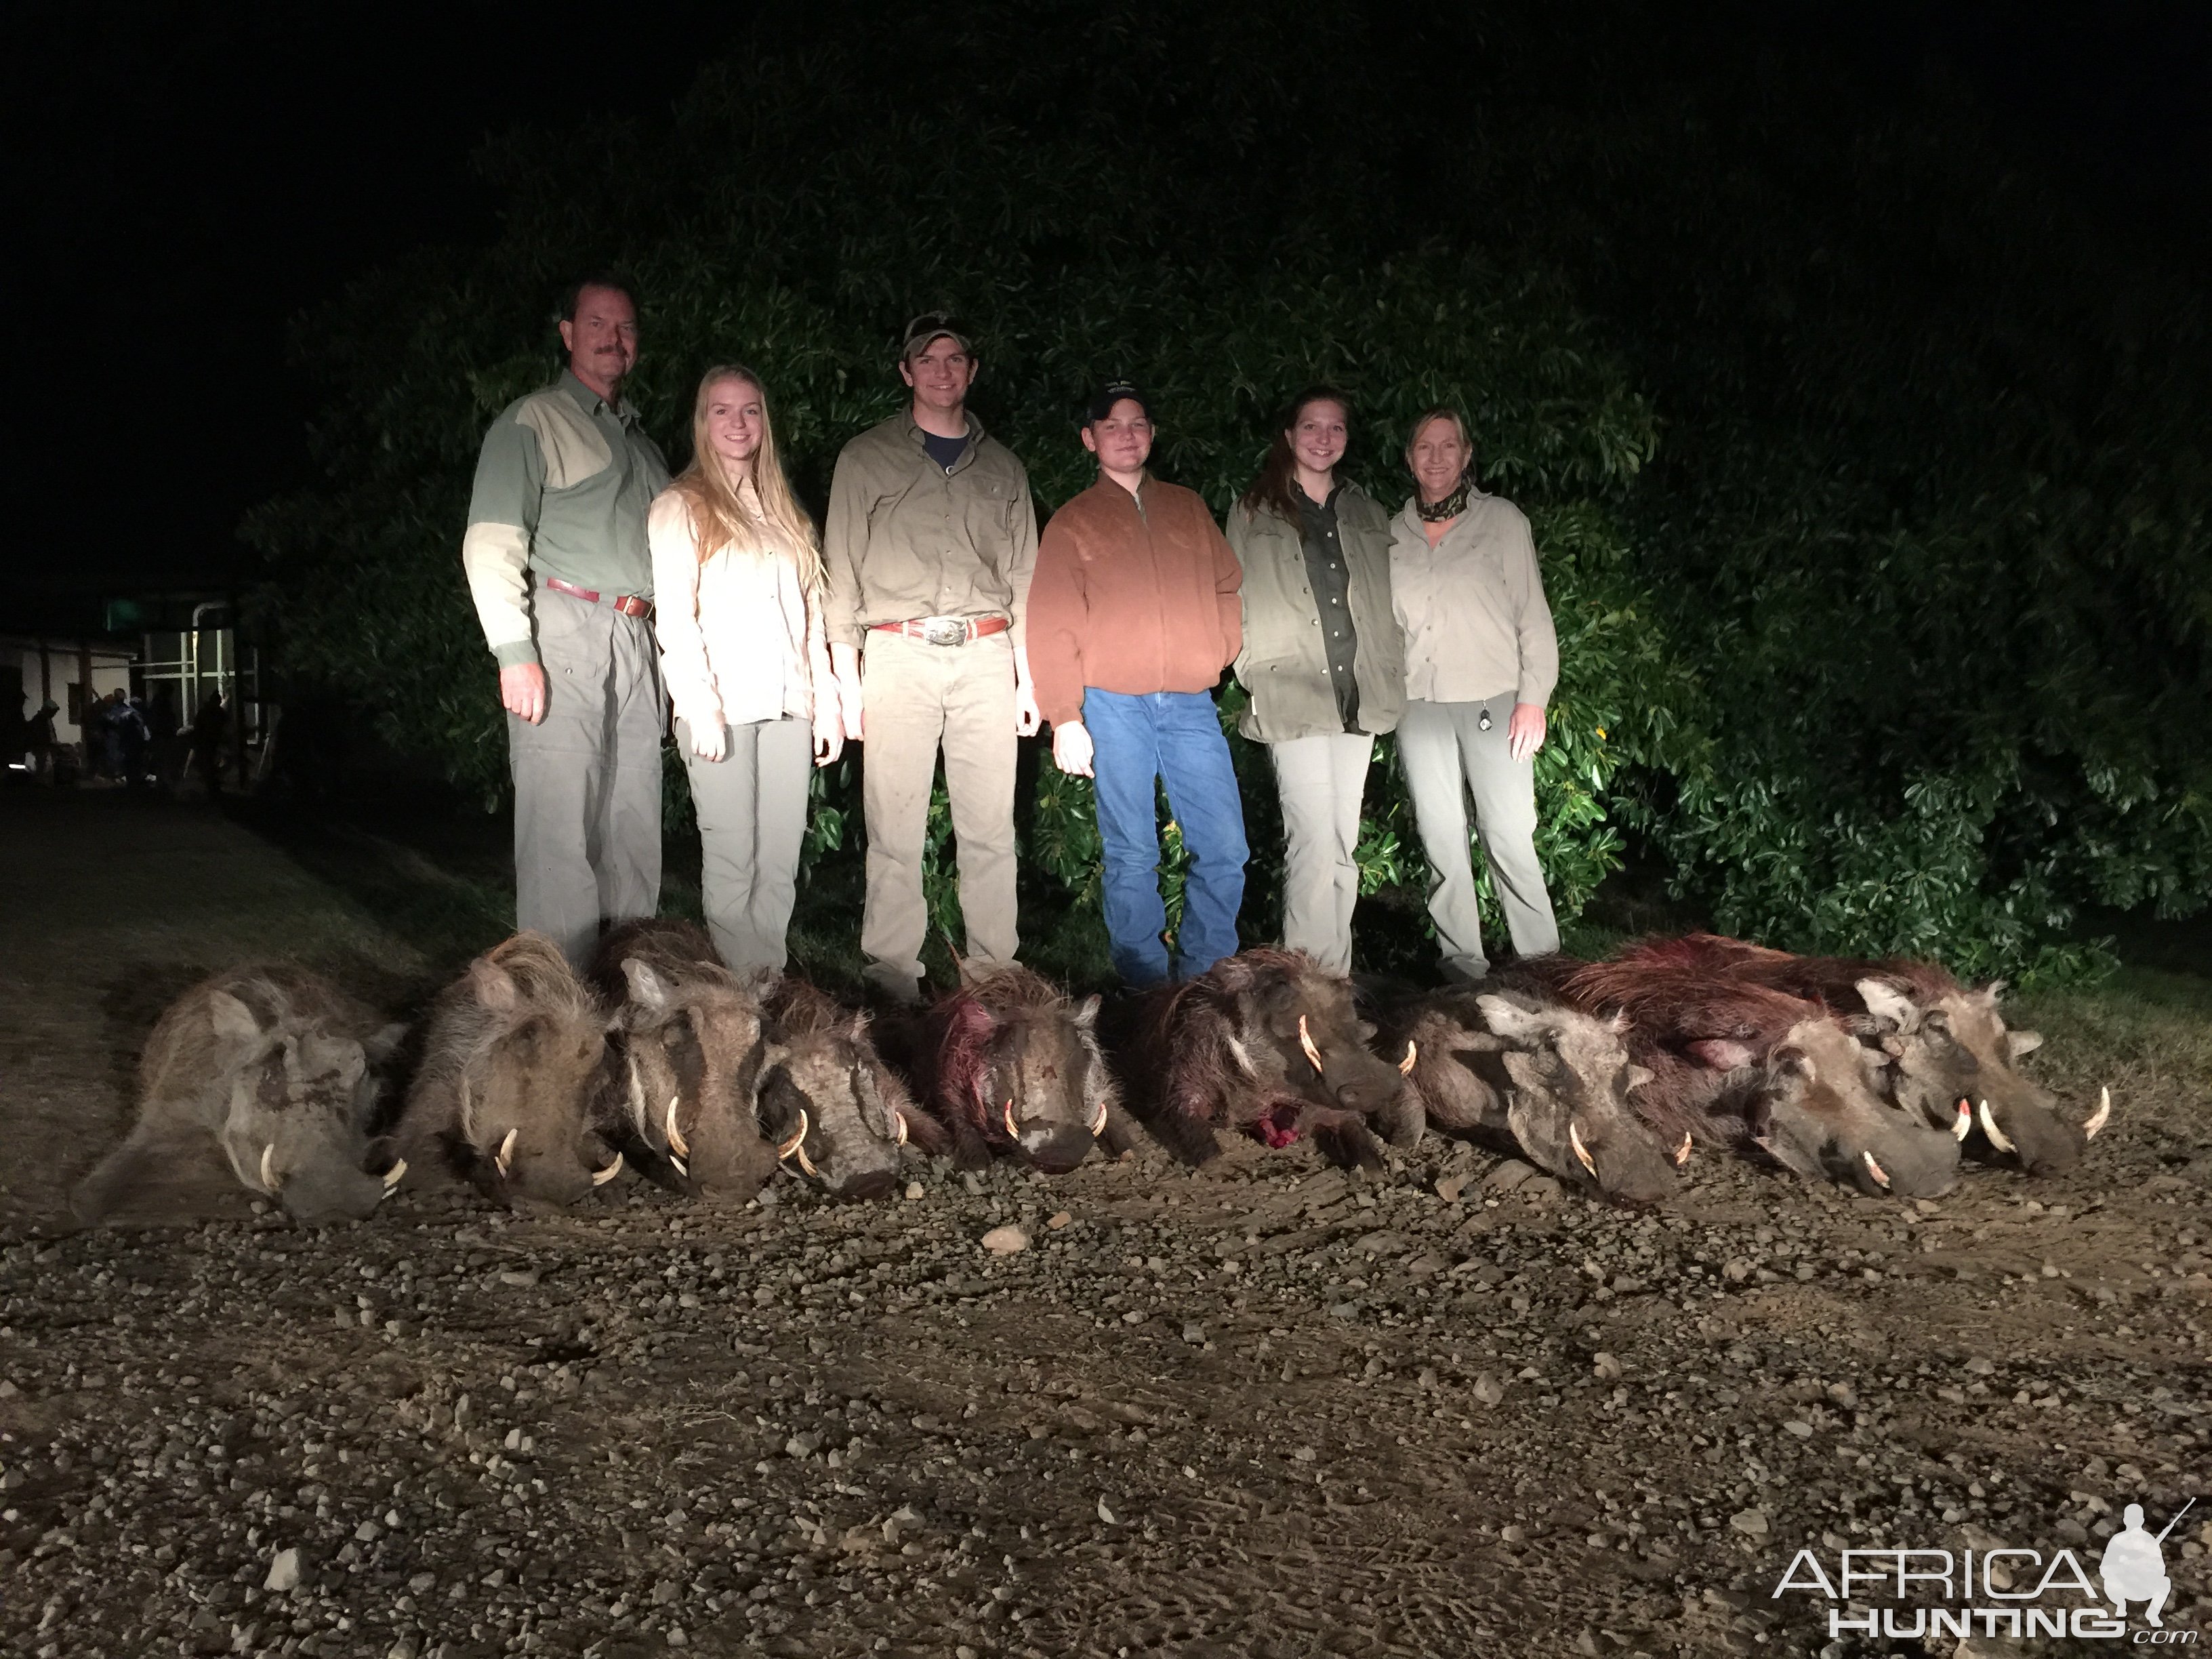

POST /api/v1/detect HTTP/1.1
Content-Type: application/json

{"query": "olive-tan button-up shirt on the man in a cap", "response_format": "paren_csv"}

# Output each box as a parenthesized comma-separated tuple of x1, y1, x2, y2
(823, 411, 1038, 651)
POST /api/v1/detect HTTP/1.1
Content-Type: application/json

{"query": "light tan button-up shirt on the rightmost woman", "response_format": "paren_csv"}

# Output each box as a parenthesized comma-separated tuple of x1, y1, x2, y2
(1389, 493, 1559, 708)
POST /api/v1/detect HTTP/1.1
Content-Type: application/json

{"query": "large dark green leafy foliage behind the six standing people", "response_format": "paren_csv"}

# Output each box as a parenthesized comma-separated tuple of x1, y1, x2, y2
(252, 0, 2212, 973)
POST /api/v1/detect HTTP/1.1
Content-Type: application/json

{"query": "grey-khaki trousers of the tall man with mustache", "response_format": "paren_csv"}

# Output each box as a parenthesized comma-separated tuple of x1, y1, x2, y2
(506, 588, 665, 966)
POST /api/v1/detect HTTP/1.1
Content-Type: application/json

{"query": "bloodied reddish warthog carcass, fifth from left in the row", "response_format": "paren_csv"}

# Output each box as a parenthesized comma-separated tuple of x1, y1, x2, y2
(907, 964, 1137, 1174)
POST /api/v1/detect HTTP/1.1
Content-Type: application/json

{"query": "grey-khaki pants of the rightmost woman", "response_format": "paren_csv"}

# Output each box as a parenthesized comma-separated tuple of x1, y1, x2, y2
(1398, 693, 1559, 980)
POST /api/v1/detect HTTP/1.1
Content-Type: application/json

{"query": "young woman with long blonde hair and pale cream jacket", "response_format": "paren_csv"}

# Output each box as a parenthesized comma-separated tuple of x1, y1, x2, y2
(646, 365, 845, 969)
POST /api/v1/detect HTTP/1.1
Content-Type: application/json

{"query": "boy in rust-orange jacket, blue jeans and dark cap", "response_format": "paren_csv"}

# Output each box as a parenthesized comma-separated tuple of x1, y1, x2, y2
(1029, 380, 1246, 987)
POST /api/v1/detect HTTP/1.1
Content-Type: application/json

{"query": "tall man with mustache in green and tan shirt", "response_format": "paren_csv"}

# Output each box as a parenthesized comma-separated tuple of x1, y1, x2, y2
(460, 276, 668, 964)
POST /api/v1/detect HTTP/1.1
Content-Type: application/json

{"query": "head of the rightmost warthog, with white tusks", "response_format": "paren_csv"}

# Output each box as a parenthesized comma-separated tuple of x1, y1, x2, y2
(1858, 978, 2112, 1174)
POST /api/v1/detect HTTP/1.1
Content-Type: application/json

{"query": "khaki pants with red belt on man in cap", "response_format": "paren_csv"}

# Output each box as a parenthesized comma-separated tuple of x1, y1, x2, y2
(861, 628, 1017, 1000)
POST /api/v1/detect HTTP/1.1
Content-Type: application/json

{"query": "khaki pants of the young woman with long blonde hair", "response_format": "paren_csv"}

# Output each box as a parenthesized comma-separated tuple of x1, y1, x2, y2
(677, 719, 814, 973)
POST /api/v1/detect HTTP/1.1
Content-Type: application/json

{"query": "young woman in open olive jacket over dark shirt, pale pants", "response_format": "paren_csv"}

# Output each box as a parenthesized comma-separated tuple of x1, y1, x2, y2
(1228, 387, 1405, 973)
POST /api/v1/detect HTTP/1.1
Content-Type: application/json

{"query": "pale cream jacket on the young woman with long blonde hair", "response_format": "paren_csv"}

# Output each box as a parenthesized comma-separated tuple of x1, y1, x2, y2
(646, 485, 830, 732)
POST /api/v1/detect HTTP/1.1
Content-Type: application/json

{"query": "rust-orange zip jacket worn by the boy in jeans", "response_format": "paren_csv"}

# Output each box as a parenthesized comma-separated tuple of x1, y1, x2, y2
(1029, 478, 1243, 726)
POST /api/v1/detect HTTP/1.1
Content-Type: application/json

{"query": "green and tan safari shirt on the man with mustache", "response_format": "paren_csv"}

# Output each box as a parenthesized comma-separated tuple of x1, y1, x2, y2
(460, 369, 668, 668)
